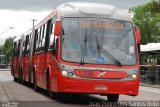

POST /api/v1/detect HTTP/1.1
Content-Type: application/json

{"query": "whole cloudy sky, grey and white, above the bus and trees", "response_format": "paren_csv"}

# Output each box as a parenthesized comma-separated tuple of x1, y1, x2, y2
(0, 0, 151, 45)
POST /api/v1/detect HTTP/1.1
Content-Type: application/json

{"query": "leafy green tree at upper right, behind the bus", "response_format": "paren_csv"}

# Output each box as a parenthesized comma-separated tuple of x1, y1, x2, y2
(129, 0, 160, 44)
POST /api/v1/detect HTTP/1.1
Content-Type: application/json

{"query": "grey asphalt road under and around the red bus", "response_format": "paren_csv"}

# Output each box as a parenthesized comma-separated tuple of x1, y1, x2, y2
(0, 69, 160, 107)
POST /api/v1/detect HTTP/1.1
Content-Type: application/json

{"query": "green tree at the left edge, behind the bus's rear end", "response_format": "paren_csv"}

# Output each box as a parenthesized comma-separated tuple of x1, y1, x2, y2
(0, 37, 15, 62)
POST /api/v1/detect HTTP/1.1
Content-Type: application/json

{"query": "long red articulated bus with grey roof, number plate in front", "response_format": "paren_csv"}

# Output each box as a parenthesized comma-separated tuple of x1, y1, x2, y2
(11, 2, 140, 101)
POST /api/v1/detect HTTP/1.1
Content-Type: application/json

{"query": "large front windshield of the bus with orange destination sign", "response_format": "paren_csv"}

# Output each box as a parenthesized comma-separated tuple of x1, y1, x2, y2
(61, 18, 136, 65)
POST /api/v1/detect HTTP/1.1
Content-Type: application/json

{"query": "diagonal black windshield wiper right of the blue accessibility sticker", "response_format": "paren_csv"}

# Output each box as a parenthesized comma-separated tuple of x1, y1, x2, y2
(100, 47, 122, 67)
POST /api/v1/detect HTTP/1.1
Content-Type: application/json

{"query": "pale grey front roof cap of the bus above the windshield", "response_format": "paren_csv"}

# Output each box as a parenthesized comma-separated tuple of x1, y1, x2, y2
(57, 2, 132, 21)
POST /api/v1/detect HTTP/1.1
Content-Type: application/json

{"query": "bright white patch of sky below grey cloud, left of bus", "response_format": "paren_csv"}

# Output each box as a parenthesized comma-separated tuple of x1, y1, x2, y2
(0, 10, 50, 45)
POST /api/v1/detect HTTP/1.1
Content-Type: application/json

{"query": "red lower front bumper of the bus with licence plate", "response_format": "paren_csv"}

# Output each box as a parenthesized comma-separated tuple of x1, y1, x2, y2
(57, 77, 139, 96)
